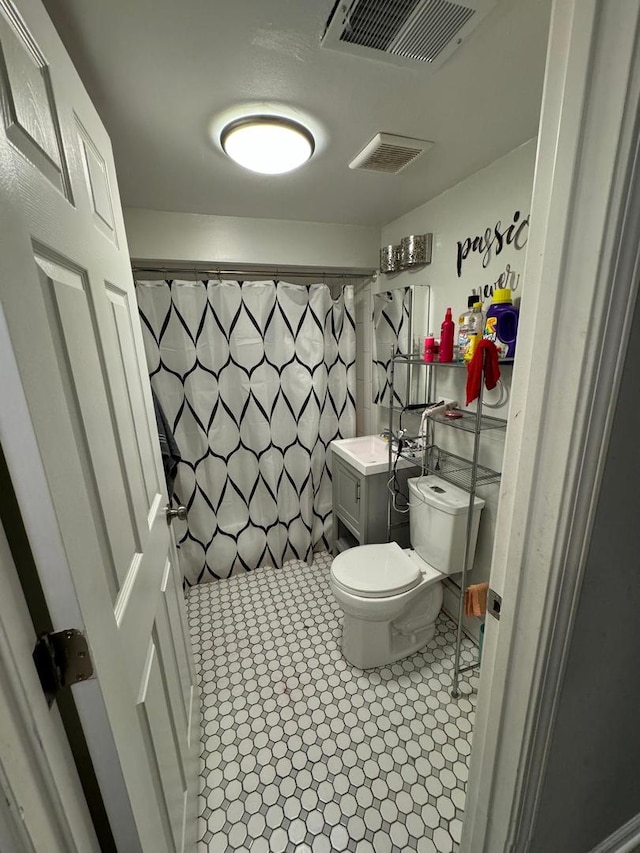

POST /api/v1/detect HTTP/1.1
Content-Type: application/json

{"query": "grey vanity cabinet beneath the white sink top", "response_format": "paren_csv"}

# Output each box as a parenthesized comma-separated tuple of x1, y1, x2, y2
(331, 453, 420, 555)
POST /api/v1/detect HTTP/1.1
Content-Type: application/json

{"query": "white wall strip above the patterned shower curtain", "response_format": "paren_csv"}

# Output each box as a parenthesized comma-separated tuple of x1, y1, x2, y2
(124, 207, 380, 270)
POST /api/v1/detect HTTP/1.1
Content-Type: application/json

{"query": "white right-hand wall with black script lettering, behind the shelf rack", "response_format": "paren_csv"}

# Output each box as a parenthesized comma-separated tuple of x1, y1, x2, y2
(357, 140, 536, 632)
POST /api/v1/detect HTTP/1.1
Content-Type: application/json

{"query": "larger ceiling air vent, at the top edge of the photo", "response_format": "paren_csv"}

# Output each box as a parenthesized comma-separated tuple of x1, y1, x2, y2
(322, 0, 497, 69)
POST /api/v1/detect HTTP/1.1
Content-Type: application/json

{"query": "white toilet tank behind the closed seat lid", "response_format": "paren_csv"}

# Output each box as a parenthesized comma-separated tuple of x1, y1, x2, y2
(407, 474, 484, 575)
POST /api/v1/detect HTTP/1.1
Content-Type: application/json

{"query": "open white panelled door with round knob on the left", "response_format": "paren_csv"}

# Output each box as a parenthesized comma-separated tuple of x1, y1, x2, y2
(0, 0, 199, 853)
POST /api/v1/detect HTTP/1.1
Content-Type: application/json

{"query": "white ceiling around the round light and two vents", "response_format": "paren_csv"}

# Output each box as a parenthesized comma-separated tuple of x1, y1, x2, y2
(45, 0, 551, 225)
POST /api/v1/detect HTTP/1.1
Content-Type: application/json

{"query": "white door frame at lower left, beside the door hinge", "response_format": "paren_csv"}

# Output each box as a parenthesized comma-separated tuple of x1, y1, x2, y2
(0, 512, 100, 853)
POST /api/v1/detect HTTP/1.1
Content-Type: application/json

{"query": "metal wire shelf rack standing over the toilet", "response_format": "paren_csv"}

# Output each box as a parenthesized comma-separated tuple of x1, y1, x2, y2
(388, 355, 509, 698)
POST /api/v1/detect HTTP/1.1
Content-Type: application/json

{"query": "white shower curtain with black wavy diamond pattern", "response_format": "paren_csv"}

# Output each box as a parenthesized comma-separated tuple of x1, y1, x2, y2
(136, 280, 355, 585)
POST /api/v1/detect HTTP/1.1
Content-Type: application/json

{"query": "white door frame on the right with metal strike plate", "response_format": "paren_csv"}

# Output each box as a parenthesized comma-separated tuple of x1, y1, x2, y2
(460, 0, 640, 853)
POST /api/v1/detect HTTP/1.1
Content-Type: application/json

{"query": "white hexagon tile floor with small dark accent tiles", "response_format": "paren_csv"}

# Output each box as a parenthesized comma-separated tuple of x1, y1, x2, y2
(188, 554, 477, 853)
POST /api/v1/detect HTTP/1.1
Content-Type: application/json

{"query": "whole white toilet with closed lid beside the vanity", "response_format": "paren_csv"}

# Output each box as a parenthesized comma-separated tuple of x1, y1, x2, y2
(330, 474, 484, 669)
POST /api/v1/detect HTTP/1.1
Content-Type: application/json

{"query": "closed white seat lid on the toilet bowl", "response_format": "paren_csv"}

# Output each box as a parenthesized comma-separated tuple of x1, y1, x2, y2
(331, 542, 422, 597)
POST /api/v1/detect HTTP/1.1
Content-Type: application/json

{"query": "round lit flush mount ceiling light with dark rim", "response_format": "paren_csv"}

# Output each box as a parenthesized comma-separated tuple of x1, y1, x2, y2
(220, 116, 315, 175)
